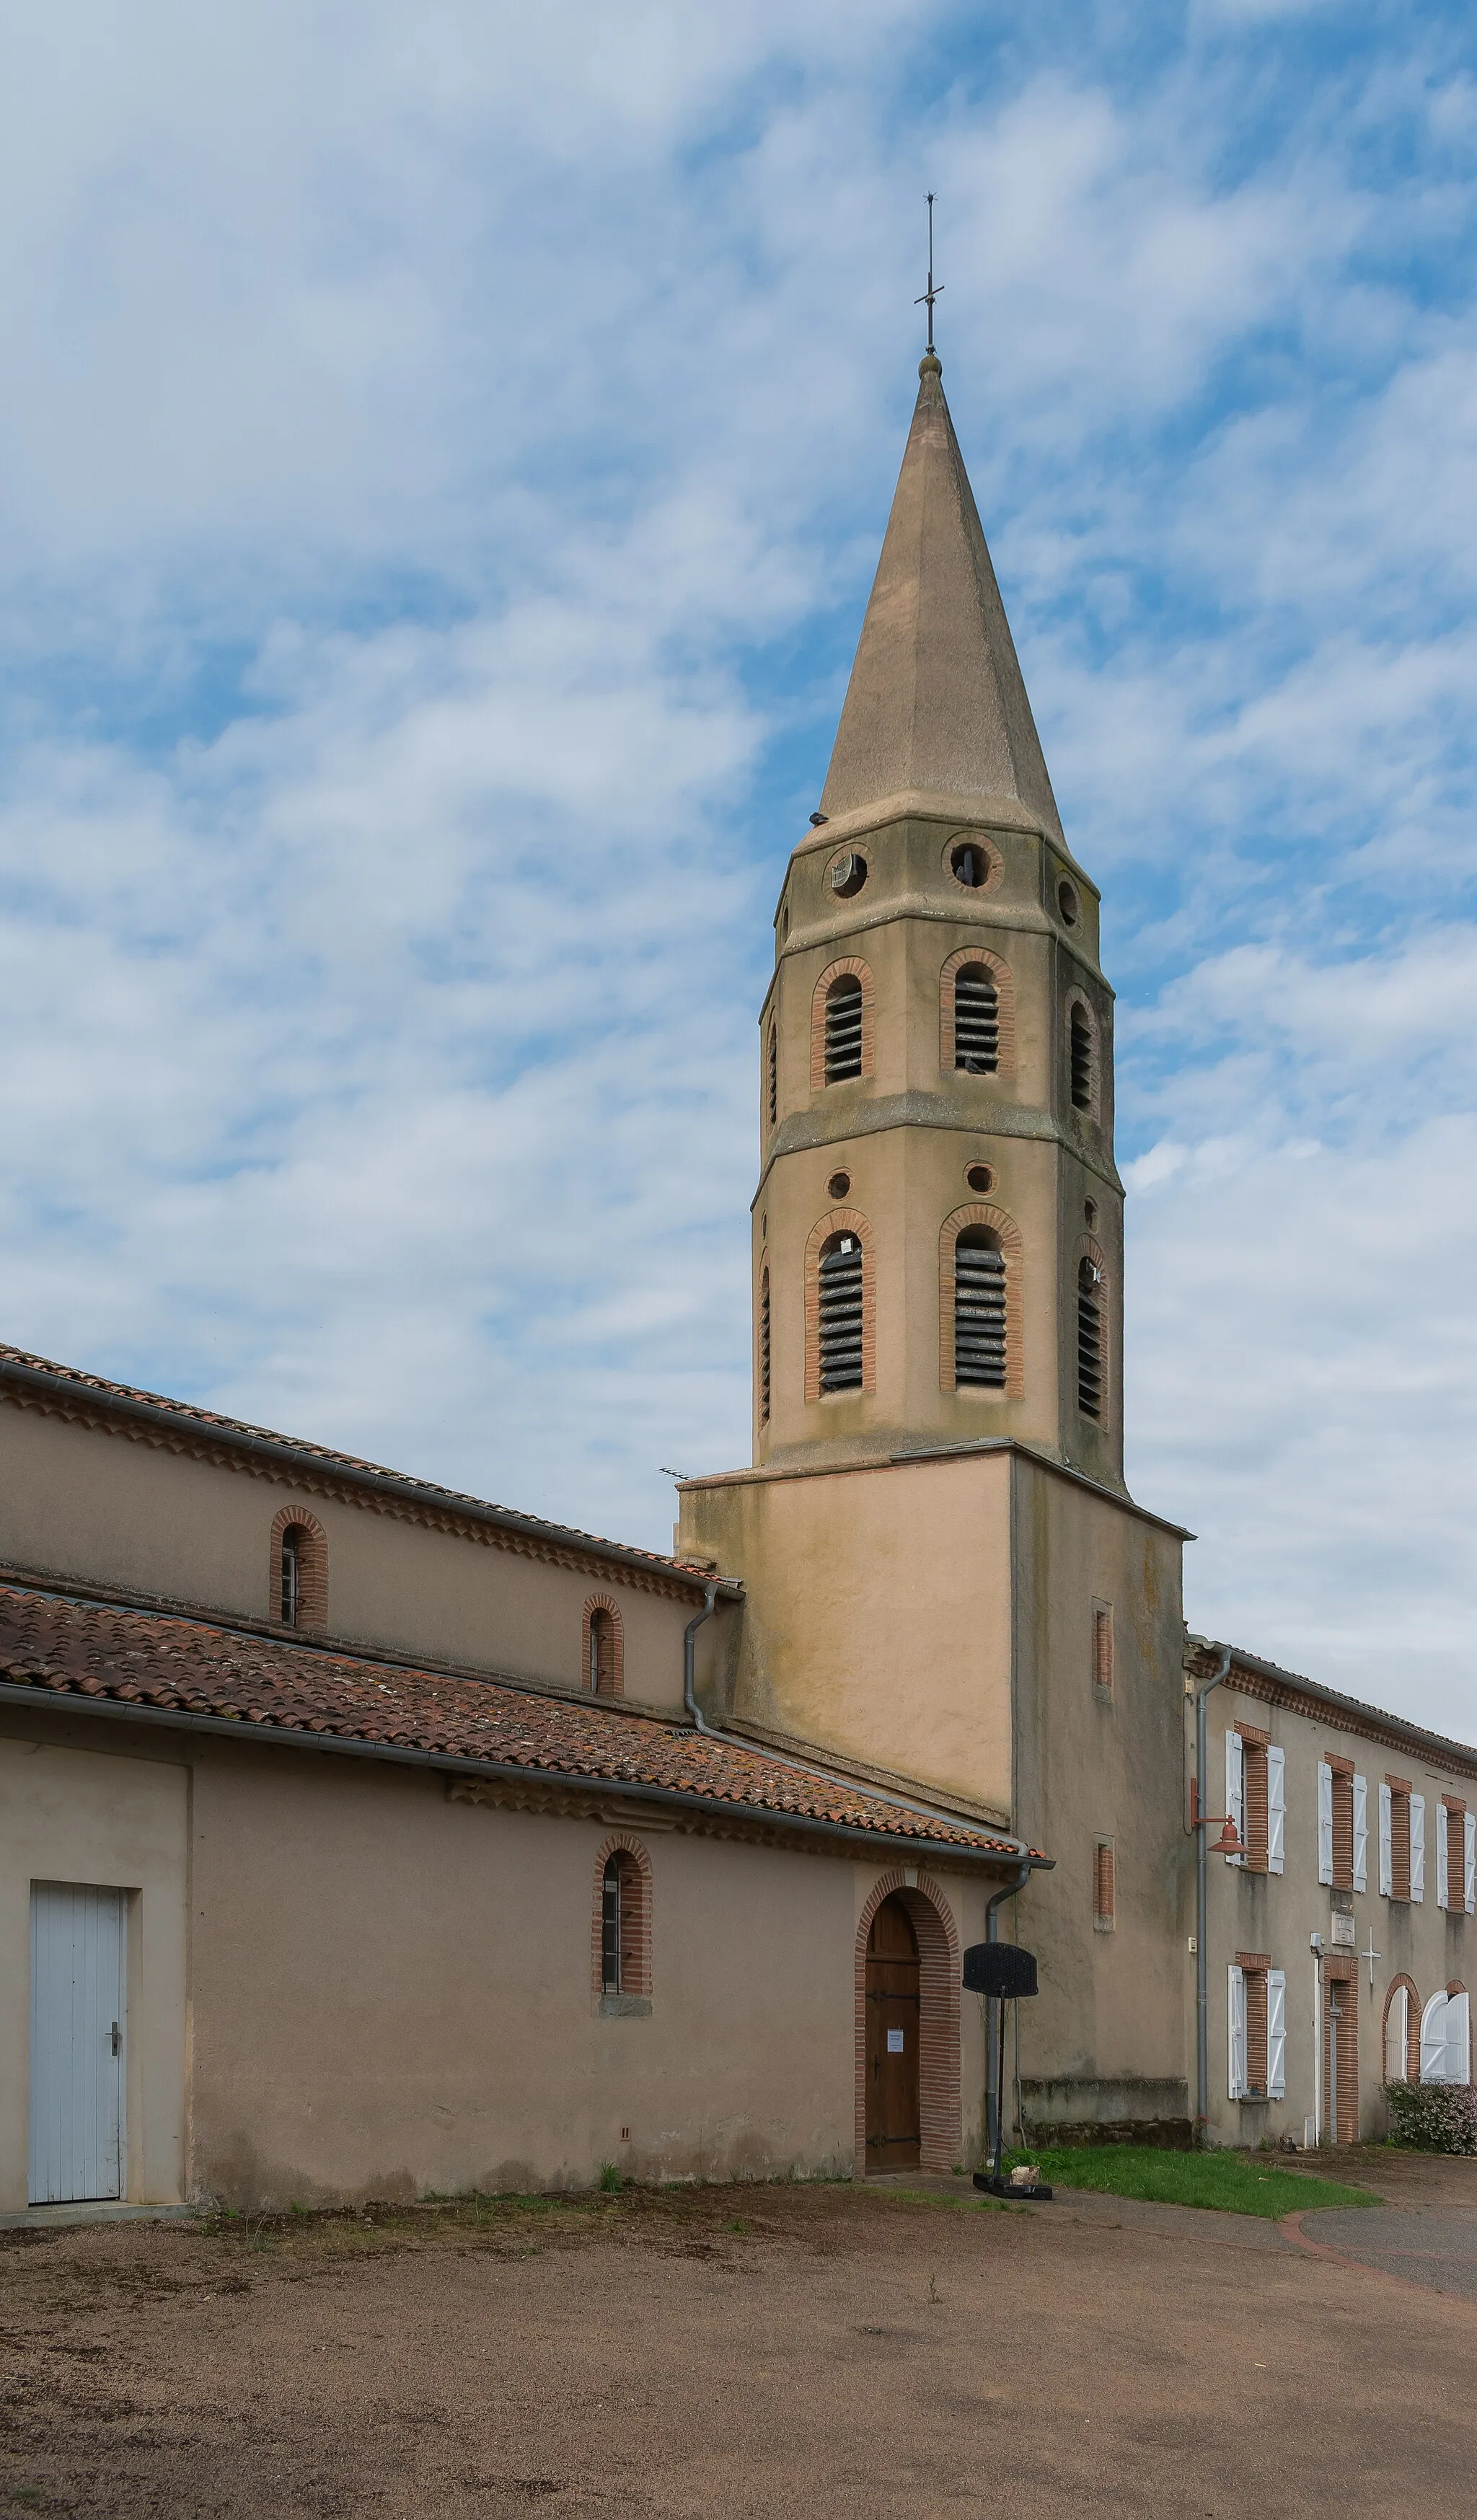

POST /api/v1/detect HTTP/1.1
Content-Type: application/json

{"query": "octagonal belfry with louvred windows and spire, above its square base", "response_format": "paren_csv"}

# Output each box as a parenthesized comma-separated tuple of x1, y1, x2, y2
(754, 353, 1121, 1486)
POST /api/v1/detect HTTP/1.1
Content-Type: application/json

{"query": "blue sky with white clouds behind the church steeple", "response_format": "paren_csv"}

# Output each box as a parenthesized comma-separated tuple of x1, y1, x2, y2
(0, 0, 1477, 1736)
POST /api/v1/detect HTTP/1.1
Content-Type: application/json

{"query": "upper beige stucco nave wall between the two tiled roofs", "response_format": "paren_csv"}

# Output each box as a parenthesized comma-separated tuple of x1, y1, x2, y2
(0, 1401, 716, 1706)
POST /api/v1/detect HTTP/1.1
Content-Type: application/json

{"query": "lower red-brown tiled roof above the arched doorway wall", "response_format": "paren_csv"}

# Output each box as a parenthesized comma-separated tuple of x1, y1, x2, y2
(0, 1585, 1018, 1855)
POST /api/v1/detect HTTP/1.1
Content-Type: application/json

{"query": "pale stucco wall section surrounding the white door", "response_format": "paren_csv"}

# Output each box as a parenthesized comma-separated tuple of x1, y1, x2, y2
(0, 1714, 189, 2213)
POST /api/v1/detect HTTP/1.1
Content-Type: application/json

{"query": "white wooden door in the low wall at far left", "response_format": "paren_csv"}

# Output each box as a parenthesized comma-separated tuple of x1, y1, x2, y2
(30, 1882, 128, 2205)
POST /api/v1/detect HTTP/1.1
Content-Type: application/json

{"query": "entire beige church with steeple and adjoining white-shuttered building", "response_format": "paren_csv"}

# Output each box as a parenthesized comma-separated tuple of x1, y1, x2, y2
(0, 353, 1477, 2218)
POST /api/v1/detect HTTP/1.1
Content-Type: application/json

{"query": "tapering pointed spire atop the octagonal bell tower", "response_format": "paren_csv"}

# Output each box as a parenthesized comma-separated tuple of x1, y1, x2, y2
(821, 353, 1061, 840)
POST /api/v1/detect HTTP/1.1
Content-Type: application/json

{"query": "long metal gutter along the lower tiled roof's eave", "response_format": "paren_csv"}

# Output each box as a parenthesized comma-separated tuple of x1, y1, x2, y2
(0, 1680, 1033, 1872)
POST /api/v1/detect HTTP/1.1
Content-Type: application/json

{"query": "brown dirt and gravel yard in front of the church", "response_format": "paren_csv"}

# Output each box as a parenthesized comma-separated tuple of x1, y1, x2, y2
(0, 2154, 1477, 2520)
